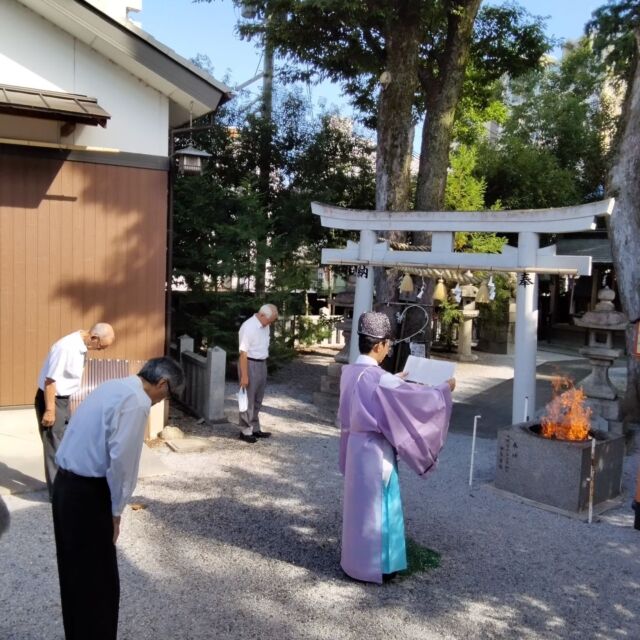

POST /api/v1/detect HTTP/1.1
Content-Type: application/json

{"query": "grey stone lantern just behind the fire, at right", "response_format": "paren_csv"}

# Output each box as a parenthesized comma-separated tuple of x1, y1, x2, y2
(573, 287, 629, 432)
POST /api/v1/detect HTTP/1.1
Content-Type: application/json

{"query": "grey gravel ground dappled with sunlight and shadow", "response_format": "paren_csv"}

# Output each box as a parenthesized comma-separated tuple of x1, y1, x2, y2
(0, 355, 640, 640)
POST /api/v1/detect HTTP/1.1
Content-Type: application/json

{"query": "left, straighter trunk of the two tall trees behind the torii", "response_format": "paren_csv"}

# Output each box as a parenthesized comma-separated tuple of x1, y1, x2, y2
(376, 0, 420, 302)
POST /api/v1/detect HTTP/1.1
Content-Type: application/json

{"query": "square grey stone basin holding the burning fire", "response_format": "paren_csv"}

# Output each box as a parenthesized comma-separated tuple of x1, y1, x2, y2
(495, 421, 624, 512)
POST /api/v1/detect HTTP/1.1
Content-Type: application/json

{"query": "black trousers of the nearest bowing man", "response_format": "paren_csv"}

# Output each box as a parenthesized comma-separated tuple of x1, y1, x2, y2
(53, 469, 120, 640)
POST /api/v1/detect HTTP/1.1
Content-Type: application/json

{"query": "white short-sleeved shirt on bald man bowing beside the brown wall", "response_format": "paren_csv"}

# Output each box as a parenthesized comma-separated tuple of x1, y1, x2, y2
(38, 331, 87, 396)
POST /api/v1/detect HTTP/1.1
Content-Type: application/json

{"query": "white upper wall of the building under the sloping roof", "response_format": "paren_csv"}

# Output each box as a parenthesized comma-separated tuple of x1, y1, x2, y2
(0, 0, 169, 156)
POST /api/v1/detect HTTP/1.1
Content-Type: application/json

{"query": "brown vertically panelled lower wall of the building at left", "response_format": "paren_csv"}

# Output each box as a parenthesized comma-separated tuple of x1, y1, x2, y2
(0, 148, 167, 406)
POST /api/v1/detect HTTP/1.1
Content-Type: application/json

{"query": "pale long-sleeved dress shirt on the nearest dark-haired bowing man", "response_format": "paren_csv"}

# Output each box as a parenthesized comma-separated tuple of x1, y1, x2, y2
(56, 376, 151, 516)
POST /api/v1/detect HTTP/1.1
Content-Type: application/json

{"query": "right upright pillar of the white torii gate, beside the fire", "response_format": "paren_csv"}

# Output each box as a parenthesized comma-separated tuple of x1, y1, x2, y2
(511, 231, 540, 424)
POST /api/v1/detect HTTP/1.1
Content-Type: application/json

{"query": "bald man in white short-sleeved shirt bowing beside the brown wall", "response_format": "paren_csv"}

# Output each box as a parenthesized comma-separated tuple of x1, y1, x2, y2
(34, 322, 115, 500)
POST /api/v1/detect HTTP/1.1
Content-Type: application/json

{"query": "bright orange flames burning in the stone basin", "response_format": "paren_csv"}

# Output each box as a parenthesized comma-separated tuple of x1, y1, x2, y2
(540, 377, 592, 440)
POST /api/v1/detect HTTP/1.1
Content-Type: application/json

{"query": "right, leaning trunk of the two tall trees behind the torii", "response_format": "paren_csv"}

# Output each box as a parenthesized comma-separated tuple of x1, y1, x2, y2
(416, 0, 480, 215)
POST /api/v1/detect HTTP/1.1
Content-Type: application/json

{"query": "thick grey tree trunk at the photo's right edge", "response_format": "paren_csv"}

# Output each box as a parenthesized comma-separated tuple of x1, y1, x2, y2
(608, 29, 640, 430)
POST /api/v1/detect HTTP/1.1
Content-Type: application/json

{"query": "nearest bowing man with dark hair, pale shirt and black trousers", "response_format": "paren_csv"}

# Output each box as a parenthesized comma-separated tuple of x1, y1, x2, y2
(53, 357, 185, 640)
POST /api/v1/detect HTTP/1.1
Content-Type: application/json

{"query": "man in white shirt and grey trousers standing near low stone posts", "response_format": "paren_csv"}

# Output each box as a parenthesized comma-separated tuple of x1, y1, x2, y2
(238, 304, 278, 444)
